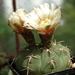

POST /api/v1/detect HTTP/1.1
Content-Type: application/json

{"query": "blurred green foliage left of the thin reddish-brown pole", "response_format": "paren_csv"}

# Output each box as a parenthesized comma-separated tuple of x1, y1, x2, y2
(0, 11, 15, 54)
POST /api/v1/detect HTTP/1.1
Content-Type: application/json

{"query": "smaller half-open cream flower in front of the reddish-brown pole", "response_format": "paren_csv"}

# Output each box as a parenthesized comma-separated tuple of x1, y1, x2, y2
(8, 9, 26, 33)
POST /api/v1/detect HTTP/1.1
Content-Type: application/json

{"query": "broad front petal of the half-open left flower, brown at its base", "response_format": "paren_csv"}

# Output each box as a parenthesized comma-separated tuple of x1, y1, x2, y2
(8, 12, 23, 30)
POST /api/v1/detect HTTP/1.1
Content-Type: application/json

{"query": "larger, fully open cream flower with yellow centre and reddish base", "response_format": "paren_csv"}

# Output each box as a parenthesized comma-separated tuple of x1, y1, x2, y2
(23, 3, 61, 34)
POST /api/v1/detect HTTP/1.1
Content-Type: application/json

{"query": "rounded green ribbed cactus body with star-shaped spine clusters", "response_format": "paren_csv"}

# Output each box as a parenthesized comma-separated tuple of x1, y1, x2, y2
(14, 42, 70, 75)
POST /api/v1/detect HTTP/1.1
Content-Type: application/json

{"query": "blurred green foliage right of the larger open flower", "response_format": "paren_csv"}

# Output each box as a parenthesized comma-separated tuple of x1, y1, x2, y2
(55, 0, 75, 55)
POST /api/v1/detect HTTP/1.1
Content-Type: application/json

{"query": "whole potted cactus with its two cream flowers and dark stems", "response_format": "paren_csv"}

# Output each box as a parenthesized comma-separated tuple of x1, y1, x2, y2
(9, 3, 71, 75)
